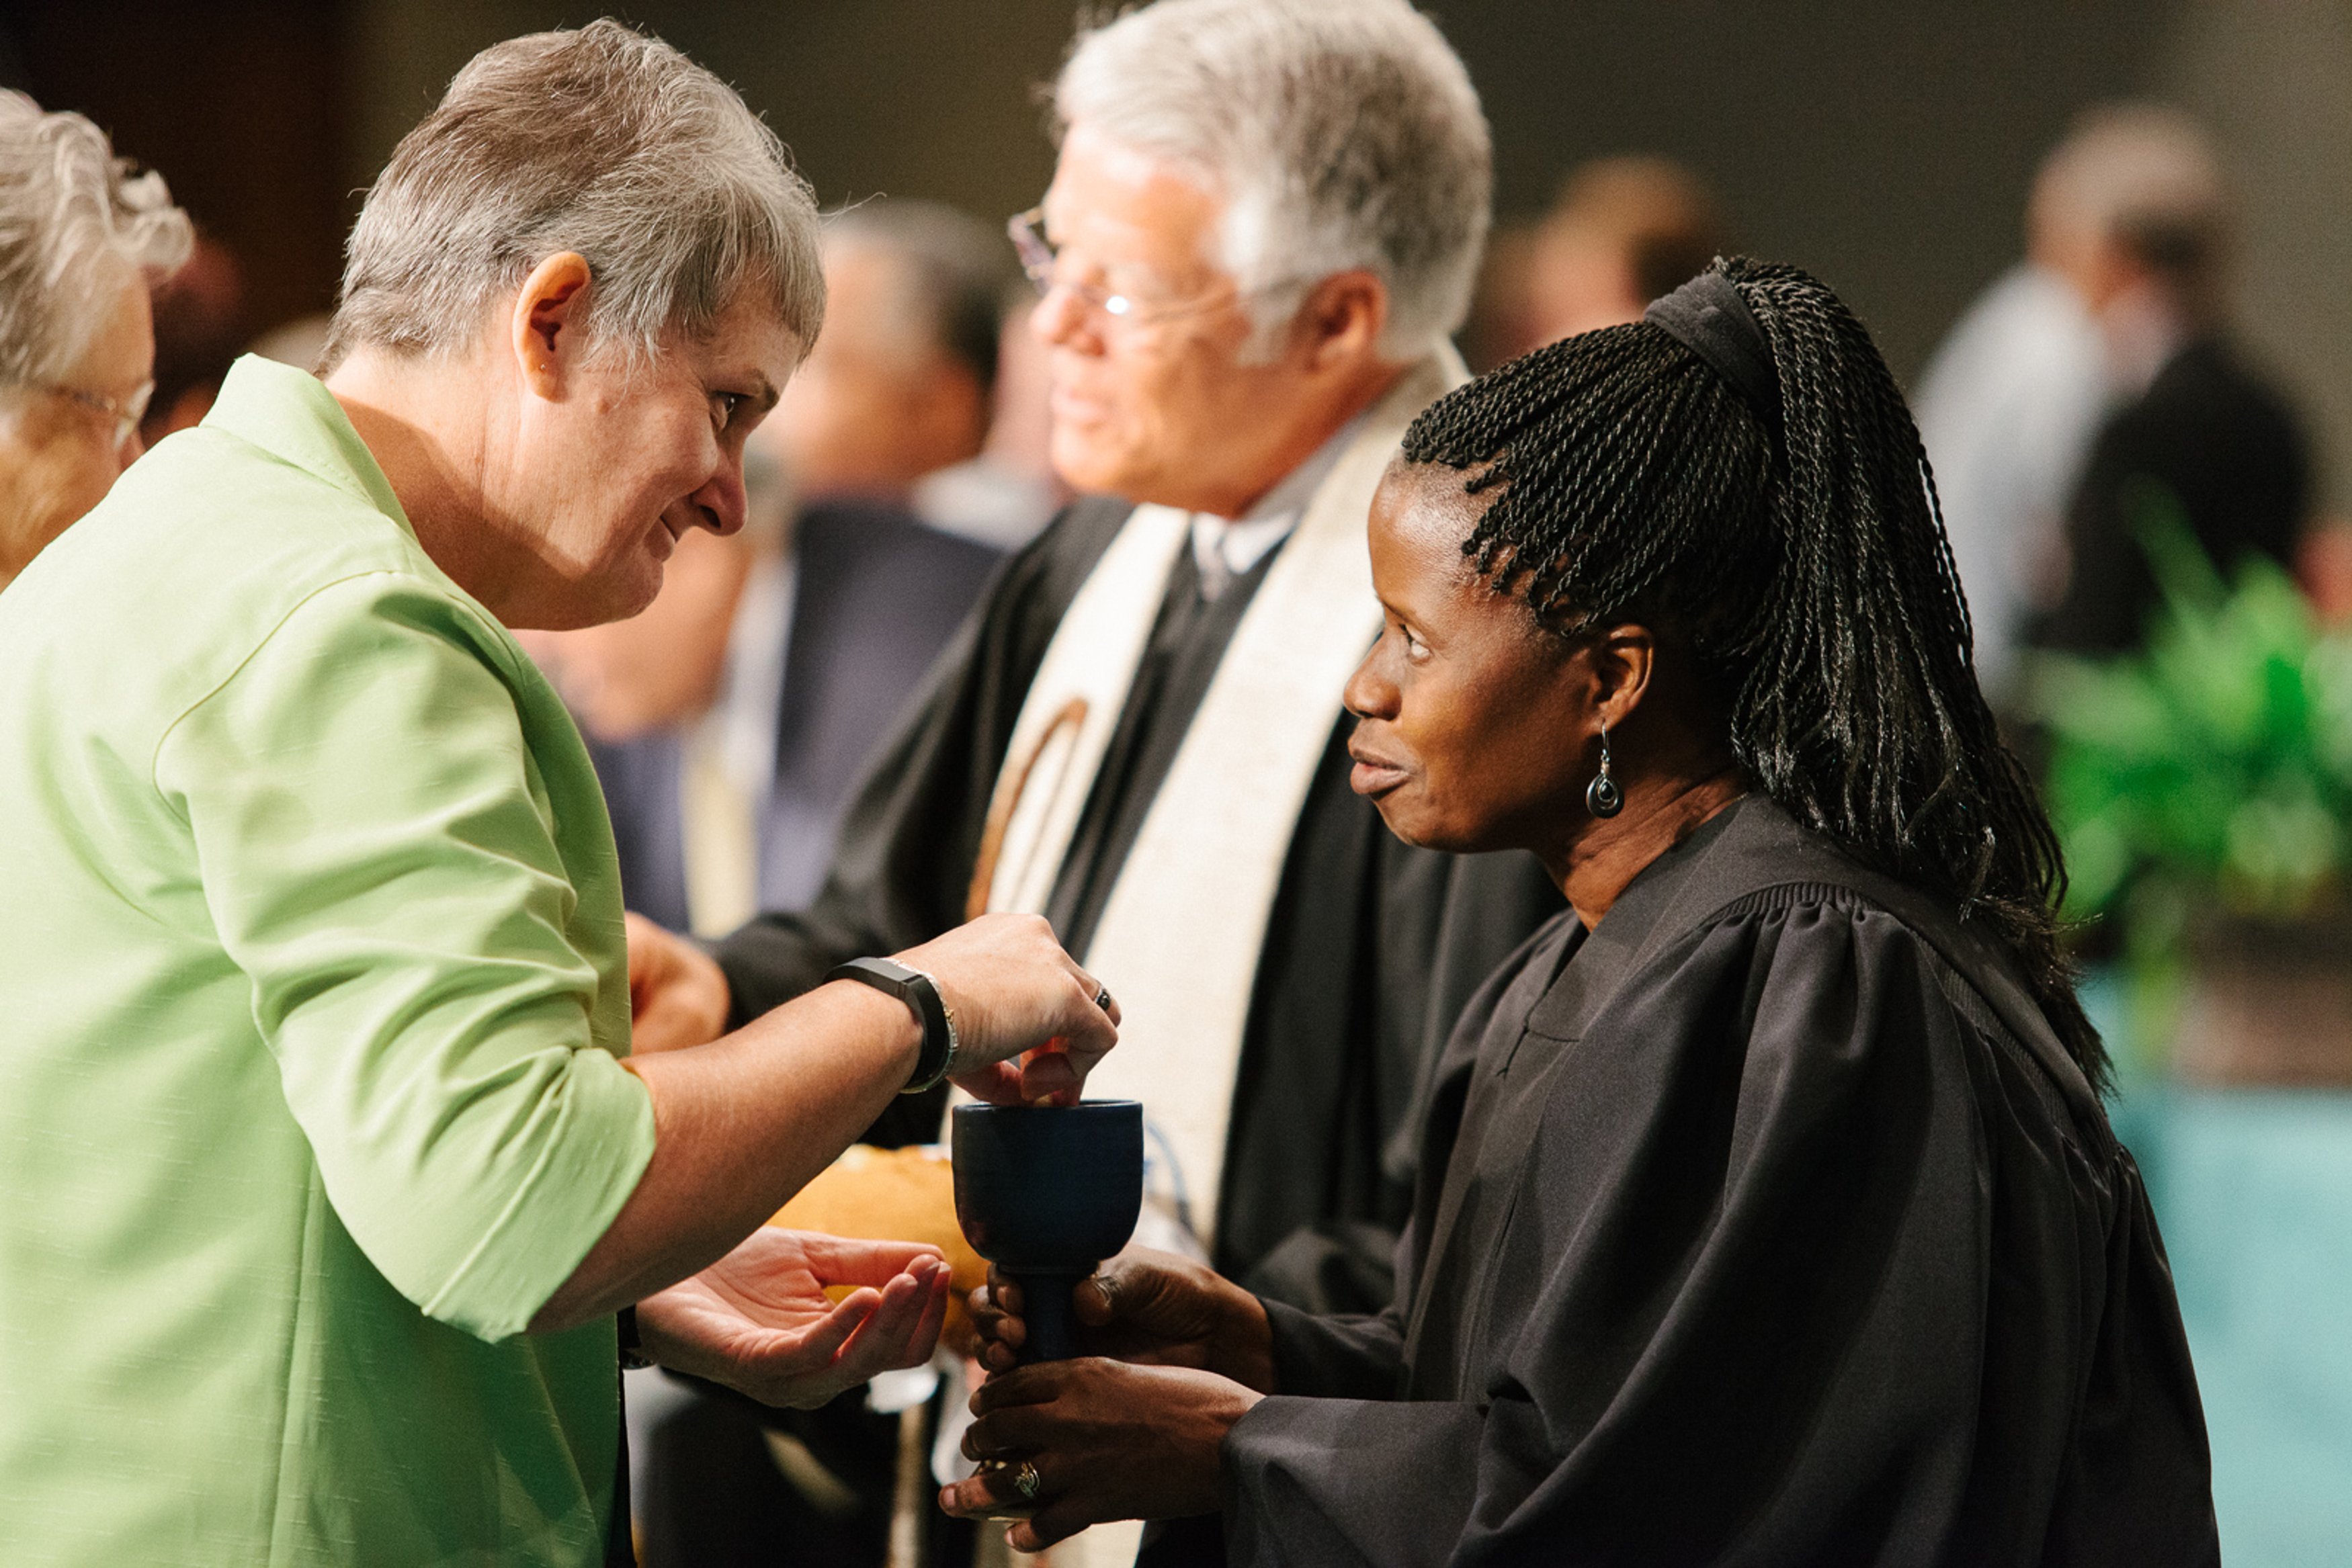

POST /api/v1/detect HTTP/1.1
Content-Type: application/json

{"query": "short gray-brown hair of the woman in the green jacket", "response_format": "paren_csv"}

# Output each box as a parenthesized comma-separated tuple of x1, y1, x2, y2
(323, 19, 826, 369)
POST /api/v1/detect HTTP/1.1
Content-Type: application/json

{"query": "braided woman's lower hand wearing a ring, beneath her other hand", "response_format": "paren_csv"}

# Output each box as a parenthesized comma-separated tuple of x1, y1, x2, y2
(939, 1356, 1261, 1552)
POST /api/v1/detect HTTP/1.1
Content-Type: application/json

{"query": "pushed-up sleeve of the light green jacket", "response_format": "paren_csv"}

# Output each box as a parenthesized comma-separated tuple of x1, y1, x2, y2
(155, 574, 654, 1340)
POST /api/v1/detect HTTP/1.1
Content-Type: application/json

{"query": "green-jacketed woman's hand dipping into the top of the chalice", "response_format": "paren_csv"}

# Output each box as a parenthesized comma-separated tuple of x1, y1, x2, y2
(896, 914, 1120, 1105)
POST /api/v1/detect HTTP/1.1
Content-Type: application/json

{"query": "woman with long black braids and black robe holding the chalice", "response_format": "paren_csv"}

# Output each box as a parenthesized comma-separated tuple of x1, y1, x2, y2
(946, 261, 2218, 1568)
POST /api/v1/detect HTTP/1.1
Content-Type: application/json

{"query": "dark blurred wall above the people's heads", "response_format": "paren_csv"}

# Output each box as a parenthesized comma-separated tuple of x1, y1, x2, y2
(0, 0, 2352, 508)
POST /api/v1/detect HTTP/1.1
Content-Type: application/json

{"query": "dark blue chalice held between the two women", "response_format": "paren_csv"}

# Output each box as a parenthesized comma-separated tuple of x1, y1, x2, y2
(950, 1100, 1143, 1361)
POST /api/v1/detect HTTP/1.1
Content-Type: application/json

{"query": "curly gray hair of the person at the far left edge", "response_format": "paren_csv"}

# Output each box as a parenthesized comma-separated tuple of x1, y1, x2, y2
(0, 91, 196, 386)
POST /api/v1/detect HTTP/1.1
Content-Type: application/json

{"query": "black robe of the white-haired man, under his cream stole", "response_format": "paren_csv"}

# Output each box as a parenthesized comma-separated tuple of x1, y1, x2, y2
(718, 500, 1560, 1309)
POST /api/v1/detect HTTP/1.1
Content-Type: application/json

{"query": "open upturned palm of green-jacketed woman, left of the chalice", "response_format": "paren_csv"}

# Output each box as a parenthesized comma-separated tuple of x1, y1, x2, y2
(638, 1225, 948, 1411)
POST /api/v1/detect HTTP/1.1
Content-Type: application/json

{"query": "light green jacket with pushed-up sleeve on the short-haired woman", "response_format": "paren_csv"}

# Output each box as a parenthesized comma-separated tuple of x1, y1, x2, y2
(0, 359, 654, 1568)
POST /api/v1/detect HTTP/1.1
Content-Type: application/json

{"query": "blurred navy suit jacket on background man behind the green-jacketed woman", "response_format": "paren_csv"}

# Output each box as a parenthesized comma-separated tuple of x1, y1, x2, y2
(588, 500, 1002, 931)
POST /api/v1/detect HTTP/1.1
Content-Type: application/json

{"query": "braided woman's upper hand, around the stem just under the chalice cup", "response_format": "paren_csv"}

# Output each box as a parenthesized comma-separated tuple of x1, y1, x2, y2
(969, 1248, 1275, 1394)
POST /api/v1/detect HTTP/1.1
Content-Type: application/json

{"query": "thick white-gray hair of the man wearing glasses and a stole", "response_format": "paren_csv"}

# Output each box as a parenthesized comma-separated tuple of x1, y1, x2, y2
(1054, 0, 1494, 357)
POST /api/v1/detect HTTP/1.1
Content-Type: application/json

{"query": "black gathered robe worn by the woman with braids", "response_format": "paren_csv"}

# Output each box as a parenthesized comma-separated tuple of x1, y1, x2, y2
(1223, 797, 2218, 1568)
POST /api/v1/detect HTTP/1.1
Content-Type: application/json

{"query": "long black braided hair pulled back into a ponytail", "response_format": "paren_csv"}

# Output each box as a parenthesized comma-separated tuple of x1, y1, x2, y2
(1404, 259, 2107, 1086)
